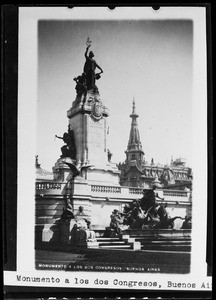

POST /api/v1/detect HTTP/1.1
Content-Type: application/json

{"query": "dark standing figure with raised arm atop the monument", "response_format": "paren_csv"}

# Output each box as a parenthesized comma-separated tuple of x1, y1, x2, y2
(83, 44, 103, 90)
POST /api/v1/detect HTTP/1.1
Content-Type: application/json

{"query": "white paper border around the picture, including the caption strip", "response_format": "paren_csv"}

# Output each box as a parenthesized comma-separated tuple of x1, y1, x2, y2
(5, 7, 211, 289)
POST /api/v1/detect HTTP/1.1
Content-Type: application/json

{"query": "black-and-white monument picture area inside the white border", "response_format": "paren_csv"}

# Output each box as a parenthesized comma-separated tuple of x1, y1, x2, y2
(35, 17, 194, 274)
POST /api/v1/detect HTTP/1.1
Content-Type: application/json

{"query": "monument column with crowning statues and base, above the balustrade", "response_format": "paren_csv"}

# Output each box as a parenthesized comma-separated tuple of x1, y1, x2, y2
(53, 41, 119, 185)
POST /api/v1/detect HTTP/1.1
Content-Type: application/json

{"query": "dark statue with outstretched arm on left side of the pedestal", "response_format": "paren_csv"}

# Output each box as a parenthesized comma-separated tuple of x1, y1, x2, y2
(55, 125, 76, 159)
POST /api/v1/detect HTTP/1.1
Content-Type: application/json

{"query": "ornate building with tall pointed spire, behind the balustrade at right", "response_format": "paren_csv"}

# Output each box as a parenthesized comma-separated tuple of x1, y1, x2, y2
(118, 100, 192, 190)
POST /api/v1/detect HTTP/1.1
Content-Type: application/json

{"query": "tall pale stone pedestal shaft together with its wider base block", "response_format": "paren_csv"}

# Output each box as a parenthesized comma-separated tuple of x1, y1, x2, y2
(67, 90, 120, 185)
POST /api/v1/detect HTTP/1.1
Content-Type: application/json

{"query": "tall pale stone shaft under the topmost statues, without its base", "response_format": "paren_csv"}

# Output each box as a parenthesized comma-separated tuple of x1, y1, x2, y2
(67, 90, 108, 166)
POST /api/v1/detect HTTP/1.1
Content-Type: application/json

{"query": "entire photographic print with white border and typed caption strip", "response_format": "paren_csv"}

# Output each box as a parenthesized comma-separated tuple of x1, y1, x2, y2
(4, 7, 211, 296)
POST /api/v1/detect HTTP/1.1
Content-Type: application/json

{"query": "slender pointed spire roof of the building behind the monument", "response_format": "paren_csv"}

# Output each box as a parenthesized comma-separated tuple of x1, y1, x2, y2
(127, 99, 144, 154)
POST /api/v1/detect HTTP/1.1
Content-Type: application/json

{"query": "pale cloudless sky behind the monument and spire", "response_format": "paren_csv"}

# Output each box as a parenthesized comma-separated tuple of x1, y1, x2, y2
(36, 20, 193, 170)
